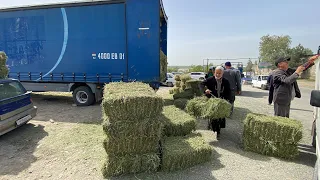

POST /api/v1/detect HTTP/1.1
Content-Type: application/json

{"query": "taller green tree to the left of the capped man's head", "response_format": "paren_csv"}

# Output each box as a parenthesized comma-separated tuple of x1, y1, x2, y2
(259, 35, 291, 65)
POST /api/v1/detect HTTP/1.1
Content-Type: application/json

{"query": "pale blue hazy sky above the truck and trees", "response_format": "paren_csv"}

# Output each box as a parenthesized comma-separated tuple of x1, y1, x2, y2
(0, 0, 320, 66)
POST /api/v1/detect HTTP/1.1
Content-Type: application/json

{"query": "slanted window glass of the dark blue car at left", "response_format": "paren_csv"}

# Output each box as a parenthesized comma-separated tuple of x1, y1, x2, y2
(0, 81, 26, 100)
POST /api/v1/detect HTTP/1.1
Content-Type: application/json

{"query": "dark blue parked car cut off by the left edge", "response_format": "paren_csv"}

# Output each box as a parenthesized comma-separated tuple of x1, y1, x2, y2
(0, 79, 37, 136)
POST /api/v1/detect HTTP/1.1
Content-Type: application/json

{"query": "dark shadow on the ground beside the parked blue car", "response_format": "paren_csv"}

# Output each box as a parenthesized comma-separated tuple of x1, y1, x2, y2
(0, 123, 48, 175)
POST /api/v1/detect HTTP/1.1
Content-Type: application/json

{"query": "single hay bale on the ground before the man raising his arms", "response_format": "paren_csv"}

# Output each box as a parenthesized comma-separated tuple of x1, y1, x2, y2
(243, 113, 302, 159)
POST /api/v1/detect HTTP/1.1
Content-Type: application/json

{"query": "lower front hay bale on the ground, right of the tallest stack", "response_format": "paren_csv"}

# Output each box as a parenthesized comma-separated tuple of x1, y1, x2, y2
(161, 134, 212, 171)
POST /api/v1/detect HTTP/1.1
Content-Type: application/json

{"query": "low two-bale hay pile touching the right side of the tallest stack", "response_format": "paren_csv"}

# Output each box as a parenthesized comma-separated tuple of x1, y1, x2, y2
(161, 106, 212, 171)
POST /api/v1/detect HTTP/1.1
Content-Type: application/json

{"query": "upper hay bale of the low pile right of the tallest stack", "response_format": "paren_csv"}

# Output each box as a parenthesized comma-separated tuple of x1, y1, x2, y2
(162, 106, 196, 136)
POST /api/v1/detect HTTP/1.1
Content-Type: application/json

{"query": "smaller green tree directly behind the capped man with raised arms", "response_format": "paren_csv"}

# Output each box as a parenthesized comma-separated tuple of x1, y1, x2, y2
(289, 44, 313, 68)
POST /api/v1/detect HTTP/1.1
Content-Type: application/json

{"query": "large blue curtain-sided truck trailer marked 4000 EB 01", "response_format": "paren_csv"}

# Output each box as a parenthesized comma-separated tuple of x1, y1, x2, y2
(0, 0, 168, 106)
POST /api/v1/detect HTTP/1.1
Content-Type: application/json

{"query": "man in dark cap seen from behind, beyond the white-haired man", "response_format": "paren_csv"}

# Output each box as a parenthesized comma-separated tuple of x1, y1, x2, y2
(223, 62, 241, 115)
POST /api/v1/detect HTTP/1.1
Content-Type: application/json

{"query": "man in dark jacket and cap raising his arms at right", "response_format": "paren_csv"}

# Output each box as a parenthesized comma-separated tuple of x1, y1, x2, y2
(271, 57, 305, 118)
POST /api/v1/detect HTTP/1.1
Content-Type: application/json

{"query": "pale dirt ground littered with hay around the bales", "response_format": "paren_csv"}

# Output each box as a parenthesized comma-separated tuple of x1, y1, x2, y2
(0, 87, 315, 180)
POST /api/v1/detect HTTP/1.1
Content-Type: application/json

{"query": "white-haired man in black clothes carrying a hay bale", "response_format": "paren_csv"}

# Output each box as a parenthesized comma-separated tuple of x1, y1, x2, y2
(200, 66, 231, 140)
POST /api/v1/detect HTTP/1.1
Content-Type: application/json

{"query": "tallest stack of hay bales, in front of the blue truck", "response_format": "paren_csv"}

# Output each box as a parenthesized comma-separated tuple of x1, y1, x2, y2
(102, 82, 163, 177)
